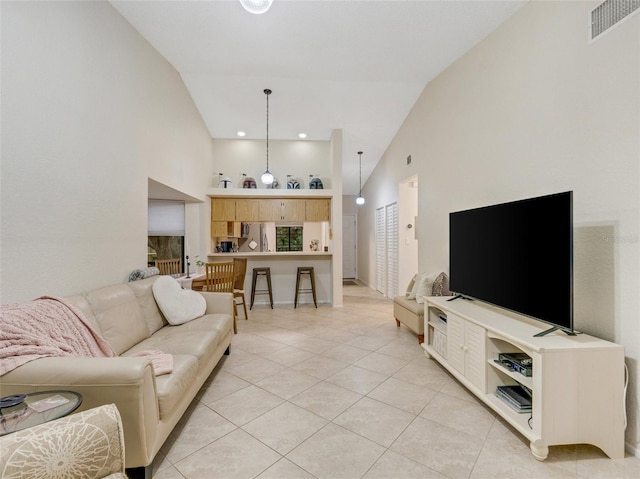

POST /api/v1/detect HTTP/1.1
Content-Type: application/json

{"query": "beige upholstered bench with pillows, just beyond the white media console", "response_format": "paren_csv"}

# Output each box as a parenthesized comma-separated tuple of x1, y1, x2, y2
(393, 273, 450, 344)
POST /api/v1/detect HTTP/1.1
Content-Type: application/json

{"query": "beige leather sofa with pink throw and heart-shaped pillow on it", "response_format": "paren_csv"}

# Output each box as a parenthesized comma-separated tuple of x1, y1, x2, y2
(0, 276, 233, 478)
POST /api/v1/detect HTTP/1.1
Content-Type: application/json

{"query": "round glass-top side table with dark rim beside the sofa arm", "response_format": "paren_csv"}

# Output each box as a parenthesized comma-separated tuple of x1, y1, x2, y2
(0, 391, 82, 436)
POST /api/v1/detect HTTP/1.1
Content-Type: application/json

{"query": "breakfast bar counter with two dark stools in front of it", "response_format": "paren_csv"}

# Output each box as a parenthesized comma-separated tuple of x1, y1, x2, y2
(207, 251, 333, 308)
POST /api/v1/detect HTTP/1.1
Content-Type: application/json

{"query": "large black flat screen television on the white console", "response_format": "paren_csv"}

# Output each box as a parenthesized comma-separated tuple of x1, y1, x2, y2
(449, 191, 573, 335)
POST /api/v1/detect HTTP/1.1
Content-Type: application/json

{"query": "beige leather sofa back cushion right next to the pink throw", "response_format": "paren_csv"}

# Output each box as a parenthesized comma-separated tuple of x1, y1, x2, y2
(83, 284, 149, 355)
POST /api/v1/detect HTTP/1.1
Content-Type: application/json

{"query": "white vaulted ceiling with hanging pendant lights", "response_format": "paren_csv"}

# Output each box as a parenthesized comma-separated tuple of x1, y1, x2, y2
(111, 0, 526, 194)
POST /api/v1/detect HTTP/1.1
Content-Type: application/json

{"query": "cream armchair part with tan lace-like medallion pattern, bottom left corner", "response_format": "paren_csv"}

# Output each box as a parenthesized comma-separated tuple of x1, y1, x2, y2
(0, 404, 126, 479)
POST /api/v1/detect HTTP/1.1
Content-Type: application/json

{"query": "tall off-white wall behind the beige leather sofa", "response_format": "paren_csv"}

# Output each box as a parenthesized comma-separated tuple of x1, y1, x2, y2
(1, 1, 212, 302)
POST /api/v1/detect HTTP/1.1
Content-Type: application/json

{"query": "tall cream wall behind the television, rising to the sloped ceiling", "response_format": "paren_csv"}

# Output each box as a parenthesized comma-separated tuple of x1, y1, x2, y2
(358, 1, 640, 455)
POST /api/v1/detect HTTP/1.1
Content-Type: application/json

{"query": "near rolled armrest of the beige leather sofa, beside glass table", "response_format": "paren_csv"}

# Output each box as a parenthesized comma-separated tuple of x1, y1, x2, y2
(0, 357, 160, 467)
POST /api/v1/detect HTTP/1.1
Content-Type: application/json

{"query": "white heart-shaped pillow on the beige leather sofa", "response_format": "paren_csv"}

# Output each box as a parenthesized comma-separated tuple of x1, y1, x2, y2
(152, 276, 207, 325)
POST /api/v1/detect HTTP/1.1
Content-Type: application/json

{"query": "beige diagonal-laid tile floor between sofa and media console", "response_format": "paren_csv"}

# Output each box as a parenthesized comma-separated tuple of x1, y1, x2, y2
(154, 286, 640, 479)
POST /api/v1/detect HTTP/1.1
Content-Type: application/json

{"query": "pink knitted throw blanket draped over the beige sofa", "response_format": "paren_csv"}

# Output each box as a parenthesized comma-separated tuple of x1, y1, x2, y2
(0, 296, 173, 376)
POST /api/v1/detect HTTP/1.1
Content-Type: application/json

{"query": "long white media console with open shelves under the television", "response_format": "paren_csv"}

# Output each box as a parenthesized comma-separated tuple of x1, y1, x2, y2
(423, 297, 625, 461)
